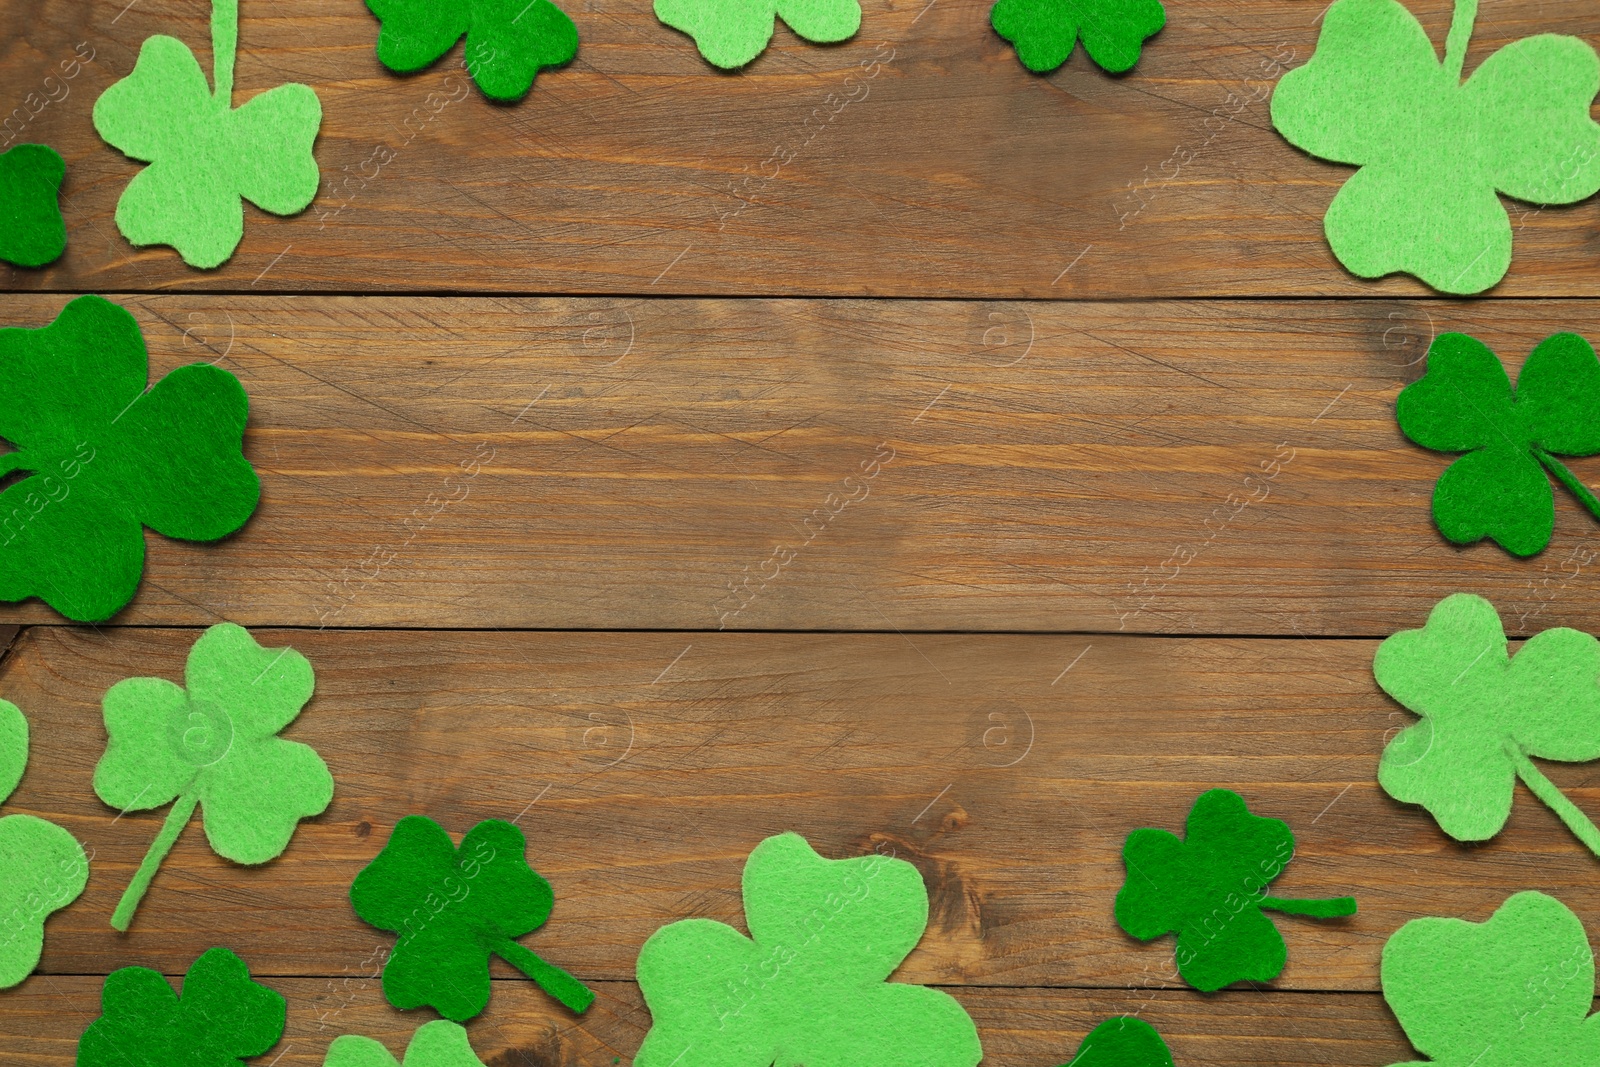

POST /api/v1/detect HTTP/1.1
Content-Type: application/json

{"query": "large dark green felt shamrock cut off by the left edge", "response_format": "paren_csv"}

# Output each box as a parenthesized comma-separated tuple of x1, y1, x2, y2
(0, 296, 261, 622)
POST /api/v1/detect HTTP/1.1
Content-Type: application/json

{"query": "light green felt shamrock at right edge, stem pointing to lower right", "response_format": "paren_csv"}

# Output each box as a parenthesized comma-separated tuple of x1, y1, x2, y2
(1373, 593, 1600, 856)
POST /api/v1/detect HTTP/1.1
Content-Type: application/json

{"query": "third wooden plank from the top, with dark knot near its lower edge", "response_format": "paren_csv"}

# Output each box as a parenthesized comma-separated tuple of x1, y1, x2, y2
(12, 627, 1600, 991)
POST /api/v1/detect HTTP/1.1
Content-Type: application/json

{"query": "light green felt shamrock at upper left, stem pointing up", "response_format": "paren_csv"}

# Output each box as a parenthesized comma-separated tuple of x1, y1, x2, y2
(94, 0, 322, 269)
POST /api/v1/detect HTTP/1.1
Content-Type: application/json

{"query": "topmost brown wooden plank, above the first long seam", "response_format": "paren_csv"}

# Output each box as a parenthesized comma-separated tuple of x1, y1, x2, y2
(0, 0, 1600, 298)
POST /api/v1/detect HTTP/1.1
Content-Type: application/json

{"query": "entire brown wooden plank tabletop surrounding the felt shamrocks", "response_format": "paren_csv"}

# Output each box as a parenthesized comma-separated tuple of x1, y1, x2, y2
(0, 0, 1600, 1067)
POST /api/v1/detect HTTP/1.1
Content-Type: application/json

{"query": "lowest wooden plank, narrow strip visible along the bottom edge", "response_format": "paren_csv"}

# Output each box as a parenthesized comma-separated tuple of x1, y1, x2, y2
(0, 976, 1410, 1067)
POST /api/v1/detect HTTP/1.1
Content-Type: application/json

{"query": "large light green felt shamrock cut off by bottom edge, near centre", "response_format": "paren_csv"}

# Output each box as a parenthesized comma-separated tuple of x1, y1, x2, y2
(634, 833, 982, 1067)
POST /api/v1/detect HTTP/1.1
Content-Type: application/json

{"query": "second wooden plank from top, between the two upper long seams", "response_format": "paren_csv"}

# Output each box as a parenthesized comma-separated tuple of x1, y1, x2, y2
(0, 296, 1600, 637)
